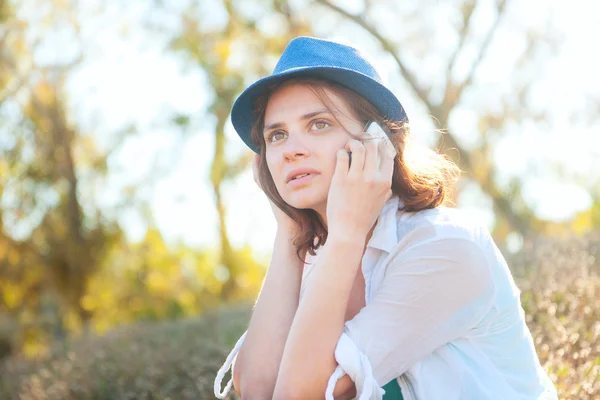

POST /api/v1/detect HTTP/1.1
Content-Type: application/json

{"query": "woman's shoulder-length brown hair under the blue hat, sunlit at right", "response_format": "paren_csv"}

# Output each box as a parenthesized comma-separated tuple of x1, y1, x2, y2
(251, 77, 461, 261)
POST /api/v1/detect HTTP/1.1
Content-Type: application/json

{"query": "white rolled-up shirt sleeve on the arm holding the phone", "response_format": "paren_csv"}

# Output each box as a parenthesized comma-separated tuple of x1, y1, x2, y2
(326, 227, 494, 400)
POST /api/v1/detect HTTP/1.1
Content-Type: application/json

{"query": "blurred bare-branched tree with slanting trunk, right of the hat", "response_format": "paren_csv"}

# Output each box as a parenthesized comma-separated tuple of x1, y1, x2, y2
(312, 0, 596, 242)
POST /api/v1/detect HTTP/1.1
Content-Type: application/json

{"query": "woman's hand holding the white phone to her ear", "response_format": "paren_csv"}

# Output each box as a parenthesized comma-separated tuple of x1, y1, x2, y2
(327, 139, 396, 240)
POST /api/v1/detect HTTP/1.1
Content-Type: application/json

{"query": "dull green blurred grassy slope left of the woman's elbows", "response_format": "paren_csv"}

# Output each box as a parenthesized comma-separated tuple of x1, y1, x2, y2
(0, 304, 250, 400)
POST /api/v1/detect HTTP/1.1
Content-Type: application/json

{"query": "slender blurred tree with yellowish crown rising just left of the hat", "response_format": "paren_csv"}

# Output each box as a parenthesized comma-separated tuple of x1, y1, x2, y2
(166, 0, 310, 301)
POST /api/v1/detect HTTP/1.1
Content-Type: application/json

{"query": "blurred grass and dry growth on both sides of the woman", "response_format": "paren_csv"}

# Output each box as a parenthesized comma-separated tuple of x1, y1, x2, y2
(0, 236, 600, 400)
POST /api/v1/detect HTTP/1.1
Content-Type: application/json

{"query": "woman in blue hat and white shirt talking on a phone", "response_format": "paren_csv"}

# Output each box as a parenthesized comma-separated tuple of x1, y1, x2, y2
(214, 37, 557, 400)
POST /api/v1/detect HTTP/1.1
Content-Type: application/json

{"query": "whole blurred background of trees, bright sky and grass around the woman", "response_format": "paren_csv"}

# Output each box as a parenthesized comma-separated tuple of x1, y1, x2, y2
(0, 0, 600, 399)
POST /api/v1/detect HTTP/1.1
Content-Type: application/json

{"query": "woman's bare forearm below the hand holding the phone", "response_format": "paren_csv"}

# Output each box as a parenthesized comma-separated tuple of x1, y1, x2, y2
(273, 235, 365, 399)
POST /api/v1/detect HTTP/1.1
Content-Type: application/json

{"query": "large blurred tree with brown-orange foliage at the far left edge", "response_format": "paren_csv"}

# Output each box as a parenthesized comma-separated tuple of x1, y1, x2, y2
(0, 2, 120, 354)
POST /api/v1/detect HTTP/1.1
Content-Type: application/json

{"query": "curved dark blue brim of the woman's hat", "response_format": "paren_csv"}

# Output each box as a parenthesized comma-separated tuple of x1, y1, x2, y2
(231, 66, 406, 154)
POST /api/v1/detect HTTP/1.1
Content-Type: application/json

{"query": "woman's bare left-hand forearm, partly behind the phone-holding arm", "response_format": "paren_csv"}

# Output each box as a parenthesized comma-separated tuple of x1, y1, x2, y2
(233, 230, 304, 399)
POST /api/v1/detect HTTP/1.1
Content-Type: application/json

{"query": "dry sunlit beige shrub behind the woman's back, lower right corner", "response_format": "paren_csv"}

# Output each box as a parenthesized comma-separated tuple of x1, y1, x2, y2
(512, 234, 600, 400)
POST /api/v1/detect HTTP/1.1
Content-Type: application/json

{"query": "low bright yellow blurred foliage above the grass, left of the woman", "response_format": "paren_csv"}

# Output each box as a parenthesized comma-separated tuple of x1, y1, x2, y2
(74, 228, 265, 332)
